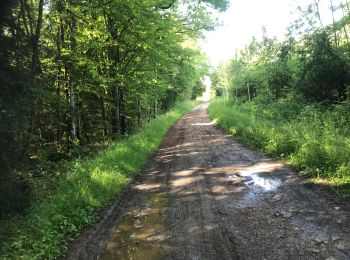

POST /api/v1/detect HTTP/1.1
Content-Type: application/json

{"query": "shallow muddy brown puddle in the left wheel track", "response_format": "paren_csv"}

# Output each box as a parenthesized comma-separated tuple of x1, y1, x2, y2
(99, 193, 169, 260)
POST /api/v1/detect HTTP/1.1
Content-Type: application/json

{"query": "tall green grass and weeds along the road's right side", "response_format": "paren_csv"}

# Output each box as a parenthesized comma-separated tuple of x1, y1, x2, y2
(209, 98, 350, 197)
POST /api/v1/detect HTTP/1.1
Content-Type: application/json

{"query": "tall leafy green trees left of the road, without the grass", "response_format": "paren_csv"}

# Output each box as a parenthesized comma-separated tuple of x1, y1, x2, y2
(0, 0, 224, 217)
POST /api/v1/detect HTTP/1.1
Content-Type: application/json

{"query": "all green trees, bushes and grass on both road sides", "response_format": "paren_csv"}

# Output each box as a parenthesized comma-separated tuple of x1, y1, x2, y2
(0, 0, 350, 259)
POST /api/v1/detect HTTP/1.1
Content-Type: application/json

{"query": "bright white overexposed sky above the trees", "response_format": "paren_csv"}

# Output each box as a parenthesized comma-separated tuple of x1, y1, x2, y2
(202, 0, 341, 66)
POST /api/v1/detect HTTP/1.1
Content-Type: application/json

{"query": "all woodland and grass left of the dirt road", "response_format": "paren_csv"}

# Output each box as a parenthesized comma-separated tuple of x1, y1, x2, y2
(0, 0, 228, 259)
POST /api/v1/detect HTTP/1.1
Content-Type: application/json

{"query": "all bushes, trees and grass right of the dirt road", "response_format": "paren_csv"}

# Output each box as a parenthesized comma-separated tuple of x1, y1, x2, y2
(209, 1, 350, 197)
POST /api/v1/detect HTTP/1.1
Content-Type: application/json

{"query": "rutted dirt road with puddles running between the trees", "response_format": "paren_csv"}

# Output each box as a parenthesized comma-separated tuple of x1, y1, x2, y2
(66, 104, 350, 260)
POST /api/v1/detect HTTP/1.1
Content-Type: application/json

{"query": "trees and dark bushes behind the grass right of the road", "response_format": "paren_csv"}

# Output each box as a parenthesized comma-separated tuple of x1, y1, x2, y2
(212, 1, 350, 103)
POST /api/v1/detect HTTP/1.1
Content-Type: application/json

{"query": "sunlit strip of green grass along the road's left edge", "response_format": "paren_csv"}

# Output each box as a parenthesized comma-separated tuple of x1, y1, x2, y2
(0, 102, 195, 259)
